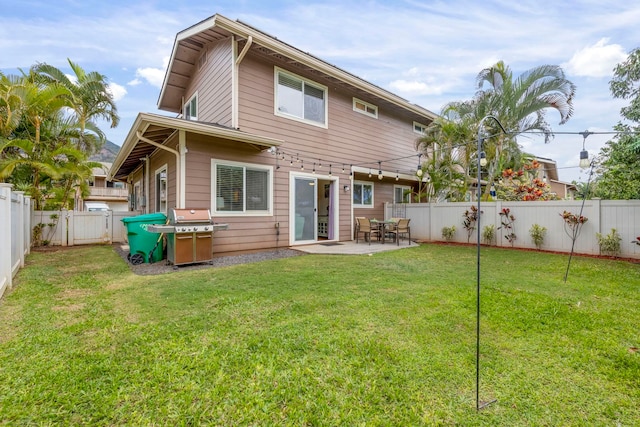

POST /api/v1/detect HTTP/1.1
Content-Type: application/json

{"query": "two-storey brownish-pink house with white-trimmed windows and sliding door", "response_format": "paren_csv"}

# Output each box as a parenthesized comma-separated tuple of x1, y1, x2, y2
(108, 15, 436, 253)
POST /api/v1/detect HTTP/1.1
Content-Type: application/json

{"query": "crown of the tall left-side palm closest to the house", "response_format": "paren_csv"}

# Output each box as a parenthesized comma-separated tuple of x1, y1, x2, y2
(31, 59, 120, 155)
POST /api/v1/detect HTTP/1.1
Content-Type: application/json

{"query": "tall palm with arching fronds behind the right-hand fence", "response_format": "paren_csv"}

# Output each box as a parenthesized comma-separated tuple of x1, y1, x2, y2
(444, 61, 576, 198)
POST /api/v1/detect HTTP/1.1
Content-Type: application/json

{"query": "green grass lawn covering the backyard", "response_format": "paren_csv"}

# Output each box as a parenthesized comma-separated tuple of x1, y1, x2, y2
(0, 245, 640, 426)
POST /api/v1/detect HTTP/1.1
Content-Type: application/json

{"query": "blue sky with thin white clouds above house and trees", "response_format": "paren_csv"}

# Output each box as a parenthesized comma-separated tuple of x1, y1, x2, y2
(0, 0, 640, 182)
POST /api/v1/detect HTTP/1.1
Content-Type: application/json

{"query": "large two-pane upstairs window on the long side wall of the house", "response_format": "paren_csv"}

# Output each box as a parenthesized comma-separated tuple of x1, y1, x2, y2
(275, 69, 327, 126)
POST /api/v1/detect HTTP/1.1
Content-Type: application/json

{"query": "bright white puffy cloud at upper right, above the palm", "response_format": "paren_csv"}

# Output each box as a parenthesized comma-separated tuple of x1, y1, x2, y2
(563, 38, 627, 77)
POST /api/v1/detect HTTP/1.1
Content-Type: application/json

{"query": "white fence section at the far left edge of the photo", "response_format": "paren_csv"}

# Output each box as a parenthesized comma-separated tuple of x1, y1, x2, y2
(0, 183, 31, 297)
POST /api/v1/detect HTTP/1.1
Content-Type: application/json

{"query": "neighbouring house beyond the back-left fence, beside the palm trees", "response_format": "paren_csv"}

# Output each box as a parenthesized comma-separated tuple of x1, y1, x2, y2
(75, 162, 129, 211)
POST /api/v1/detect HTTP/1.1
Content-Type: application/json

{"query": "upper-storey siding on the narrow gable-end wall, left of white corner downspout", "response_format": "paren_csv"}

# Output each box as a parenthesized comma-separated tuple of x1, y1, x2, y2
(184, 39, 233, 126)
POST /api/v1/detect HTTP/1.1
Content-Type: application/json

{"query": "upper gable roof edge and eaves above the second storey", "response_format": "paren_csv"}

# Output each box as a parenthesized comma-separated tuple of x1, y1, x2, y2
(158, 14, 437, 120)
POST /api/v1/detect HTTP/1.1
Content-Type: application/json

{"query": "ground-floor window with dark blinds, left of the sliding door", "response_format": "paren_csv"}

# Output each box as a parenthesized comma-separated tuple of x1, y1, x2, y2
(211, 162, 272, 215)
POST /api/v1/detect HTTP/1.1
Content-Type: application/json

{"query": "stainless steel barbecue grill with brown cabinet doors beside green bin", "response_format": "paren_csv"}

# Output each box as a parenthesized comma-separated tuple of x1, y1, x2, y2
(147, 209, 229, 266)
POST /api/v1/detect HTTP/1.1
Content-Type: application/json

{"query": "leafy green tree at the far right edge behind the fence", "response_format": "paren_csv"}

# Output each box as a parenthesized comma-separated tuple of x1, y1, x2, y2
(595, 48, 640, 199)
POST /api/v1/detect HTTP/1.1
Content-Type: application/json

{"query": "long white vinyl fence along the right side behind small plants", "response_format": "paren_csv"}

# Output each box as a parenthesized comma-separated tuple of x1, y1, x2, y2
(385, 200, 640, 258)
